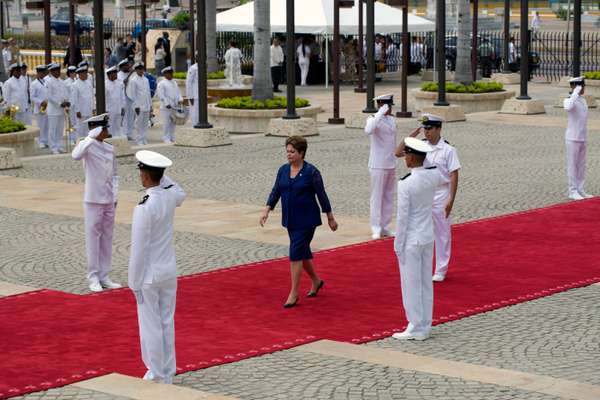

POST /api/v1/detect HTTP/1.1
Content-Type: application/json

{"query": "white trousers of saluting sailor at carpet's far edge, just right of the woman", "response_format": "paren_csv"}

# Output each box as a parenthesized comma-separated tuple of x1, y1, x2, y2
(369, 168, 398, 235)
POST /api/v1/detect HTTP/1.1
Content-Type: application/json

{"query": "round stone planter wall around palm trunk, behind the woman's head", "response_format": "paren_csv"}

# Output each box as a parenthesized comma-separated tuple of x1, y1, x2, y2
(208, 104, 322, 133)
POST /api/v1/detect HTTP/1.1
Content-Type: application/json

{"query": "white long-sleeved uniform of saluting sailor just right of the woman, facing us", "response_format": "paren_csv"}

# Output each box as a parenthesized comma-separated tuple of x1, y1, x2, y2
(365, 106, 396, 235)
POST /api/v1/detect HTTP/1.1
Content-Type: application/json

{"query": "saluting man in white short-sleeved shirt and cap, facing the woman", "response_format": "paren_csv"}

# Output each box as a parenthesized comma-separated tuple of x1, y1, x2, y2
(396, 114, 460, 282)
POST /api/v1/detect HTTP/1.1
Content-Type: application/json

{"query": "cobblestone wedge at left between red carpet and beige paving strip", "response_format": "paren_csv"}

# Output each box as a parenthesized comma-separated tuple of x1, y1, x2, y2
(0, 207, 288, 293)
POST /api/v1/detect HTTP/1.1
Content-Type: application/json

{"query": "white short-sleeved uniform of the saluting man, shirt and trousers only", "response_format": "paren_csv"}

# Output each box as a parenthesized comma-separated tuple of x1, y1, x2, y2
(423, 137, 460, 276)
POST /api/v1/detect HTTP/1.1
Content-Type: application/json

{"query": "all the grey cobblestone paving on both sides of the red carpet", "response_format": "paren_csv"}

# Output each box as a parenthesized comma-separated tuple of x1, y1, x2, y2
(0, 79, 600, 400)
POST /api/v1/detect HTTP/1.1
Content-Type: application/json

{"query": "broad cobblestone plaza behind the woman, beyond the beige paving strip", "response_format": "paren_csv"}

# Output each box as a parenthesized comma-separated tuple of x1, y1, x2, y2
(2, 120, 600, 222)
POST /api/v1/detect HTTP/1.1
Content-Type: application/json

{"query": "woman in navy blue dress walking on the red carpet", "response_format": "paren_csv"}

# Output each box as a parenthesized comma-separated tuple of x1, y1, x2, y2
(260, 136, 338, 308)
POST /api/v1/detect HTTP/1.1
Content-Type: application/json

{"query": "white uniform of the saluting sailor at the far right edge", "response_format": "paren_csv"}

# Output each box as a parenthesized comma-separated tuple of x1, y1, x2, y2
(563, 86, 588, 196)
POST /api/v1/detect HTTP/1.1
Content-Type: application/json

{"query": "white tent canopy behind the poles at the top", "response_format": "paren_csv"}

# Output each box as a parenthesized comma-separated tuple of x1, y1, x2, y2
(217, 0, 435, 35)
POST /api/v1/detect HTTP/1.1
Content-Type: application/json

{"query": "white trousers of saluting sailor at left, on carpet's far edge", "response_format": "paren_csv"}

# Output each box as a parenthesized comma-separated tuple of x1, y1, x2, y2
(83, 202, 115, 282)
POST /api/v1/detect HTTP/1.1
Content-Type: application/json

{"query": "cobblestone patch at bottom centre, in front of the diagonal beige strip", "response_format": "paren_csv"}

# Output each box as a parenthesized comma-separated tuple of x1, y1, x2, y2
(174, 350, 555, 400)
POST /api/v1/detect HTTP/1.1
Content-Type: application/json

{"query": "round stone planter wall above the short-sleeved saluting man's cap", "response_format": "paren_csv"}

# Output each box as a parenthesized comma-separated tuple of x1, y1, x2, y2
(411, 89, 515, 114)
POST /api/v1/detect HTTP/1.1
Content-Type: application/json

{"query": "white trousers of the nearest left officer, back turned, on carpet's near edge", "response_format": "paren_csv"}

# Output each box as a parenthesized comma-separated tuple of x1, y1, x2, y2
(137, 279, 177, 383)
